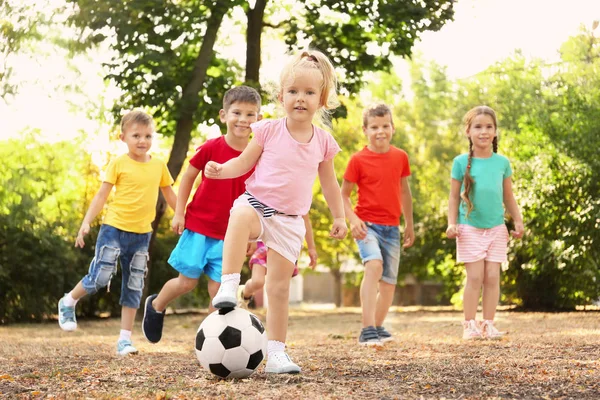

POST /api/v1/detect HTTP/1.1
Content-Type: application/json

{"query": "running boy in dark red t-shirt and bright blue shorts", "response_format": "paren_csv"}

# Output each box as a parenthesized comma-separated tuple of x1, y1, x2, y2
(142, 86, 261, 343)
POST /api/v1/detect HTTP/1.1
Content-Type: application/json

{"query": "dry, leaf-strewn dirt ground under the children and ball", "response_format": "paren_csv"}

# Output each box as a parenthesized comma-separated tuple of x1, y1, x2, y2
(0, 307, 600, 400)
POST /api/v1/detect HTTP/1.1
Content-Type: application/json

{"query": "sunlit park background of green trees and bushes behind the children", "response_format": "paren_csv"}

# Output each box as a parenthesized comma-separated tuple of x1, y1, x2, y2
(0, 0, 600, 324)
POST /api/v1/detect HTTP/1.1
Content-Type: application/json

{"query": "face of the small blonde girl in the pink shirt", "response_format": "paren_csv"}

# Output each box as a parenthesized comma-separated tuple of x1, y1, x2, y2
(280, 68, 323, 122)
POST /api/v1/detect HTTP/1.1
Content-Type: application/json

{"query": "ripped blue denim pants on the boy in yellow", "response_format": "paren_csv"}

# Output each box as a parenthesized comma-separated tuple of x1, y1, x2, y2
(81, 225, 152, 308)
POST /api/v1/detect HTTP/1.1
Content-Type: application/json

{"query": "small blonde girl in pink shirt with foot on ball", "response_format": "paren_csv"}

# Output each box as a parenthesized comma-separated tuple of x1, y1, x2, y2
(204, 51, 347, 374)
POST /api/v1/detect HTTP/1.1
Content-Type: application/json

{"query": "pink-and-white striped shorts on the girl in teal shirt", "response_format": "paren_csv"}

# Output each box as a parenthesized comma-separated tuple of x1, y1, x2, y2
(456, 224, 508, 263)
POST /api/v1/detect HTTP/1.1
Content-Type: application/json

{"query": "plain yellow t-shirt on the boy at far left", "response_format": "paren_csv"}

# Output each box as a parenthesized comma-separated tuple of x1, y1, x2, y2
(103, 154, 173, 233)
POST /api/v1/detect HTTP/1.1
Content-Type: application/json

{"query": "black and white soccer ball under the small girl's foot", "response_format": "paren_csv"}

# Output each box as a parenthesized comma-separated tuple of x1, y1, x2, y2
(196, 308, 267, 378)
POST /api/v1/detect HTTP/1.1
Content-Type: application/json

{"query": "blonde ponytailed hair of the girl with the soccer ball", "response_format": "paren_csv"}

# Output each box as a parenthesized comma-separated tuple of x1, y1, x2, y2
(279, 49, 340, 125)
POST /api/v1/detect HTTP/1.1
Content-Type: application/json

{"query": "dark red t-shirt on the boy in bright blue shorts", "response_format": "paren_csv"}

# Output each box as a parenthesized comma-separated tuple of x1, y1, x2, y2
(185, 136, 254, 240)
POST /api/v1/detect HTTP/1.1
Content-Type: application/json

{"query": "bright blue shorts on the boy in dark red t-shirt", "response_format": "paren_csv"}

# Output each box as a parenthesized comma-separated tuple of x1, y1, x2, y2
(169, 229, 223, 282)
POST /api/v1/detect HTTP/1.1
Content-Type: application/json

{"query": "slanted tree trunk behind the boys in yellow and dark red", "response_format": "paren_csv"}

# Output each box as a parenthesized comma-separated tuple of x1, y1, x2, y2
(144, 1, 233, 295)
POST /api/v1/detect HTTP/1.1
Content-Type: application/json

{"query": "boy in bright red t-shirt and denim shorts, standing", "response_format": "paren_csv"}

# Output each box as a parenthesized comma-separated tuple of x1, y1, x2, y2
(342, 104, 414, 346)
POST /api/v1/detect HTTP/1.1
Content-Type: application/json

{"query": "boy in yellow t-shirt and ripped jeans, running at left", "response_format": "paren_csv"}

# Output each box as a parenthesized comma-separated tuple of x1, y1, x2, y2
(58, 110, 177, 356)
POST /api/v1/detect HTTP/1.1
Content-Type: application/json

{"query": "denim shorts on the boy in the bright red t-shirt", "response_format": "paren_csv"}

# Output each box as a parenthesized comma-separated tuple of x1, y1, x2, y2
(356, 222, 400, 285)
